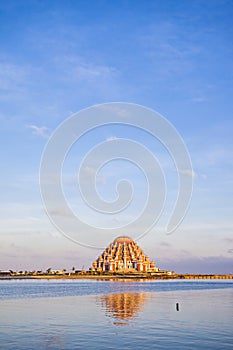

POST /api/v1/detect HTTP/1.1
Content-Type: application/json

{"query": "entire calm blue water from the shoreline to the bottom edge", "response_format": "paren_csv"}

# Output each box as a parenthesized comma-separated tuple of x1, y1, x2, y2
(0, 280, 233, 350)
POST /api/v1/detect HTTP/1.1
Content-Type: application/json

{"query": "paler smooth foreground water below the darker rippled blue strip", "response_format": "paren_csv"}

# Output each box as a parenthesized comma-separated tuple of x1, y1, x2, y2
(0, 282, 233, 350)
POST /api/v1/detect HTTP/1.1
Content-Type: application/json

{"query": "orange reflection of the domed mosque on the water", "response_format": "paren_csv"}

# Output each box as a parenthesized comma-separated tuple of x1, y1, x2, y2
(97, 293, 149, 325)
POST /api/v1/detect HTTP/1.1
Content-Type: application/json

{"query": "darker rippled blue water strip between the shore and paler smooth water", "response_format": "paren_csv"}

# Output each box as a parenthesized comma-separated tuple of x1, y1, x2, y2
(0, 279, 233, 300)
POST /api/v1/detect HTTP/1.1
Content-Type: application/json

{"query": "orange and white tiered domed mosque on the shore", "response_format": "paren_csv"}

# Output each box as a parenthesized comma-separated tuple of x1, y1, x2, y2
(92, 236, 160, 273)
